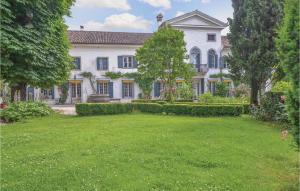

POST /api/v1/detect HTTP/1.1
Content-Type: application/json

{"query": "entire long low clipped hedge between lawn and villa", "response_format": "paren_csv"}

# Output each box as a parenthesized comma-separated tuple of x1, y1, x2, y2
(76, 103, 243, 116)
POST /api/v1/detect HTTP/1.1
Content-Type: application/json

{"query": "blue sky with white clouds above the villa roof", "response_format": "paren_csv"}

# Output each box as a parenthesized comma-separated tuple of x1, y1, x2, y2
(65, 0, 233, 35)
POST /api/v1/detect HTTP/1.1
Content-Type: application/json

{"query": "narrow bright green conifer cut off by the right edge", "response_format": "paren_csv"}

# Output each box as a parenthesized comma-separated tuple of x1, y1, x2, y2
(277, 0, 300, 148)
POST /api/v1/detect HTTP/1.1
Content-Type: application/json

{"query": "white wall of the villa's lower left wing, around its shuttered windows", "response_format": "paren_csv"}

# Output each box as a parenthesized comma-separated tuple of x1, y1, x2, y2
(68, 45, 139, 102)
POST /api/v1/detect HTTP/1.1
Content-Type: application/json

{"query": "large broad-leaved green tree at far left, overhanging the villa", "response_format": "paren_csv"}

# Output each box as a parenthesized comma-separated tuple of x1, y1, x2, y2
(0, 0, 73, 100)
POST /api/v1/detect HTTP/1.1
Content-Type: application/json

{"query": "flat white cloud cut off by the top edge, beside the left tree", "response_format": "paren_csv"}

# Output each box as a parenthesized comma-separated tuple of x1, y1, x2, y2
(75, 0, 131, 11)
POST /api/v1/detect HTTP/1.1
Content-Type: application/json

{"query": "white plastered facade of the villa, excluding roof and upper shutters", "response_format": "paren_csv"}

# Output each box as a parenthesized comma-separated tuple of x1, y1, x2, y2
(32, 10, 232, 103)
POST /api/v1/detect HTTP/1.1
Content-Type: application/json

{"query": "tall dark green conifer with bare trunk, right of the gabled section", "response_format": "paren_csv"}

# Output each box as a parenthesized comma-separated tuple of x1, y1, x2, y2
(227, 0, 282, 104)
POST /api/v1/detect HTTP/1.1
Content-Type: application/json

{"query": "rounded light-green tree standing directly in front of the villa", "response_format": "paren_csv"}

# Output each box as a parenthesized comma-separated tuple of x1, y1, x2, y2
(136, 26, 195, 101)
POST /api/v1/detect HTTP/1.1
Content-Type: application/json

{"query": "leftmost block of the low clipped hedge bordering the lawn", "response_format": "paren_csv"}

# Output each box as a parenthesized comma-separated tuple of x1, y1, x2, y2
(75, 103, 133, 116)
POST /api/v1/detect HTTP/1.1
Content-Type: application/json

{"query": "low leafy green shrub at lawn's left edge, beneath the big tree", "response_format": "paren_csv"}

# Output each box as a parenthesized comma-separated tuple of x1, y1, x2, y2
(0, 102, 53, 122)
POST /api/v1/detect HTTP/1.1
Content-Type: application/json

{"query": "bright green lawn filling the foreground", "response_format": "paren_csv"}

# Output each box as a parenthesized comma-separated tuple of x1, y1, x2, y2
(1, 114, 298, 191)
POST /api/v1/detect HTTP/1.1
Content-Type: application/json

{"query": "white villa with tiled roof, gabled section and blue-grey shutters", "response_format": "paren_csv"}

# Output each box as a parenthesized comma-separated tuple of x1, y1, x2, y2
(28, 10, 233, 103)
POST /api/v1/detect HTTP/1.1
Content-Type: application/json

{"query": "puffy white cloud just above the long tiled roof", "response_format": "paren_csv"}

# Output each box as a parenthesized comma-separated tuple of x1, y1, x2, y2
(79, 13, 151, 31)
